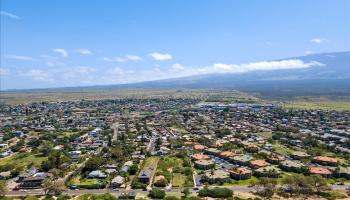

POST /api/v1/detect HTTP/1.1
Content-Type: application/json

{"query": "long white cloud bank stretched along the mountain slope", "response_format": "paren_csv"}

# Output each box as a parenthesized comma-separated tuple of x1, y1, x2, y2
(98, 59, 323, 84)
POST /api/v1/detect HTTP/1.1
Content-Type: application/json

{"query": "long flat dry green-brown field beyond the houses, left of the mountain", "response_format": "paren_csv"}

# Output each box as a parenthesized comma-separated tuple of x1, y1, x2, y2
(0, 88, 249, 105)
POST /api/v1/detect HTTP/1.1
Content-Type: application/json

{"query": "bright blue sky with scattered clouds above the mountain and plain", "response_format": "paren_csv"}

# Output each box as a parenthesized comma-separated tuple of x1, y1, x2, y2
(0, 0, 350, 90)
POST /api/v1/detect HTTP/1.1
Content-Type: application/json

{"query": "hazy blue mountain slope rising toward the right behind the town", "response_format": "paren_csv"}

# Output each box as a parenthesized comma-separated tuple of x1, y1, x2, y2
(5, 51, 350, 97)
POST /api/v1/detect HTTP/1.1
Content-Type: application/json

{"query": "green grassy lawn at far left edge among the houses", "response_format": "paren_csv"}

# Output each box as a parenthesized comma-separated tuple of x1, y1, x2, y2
(0, 153, 47, 167)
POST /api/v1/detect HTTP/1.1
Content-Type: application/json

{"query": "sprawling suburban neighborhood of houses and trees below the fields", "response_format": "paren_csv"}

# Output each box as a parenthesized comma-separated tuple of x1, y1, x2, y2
(0, 97, 350, 199)
